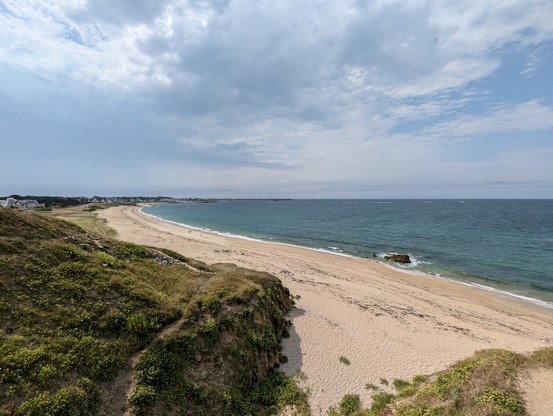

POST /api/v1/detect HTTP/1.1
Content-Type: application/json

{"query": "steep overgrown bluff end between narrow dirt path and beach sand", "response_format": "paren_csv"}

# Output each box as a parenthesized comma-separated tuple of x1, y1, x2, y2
(131, 268, 306, 415)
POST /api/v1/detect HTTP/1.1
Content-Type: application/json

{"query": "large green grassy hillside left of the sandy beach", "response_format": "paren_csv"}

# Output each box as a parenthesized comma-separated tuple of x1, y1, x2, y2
(0, 209, 309, 416)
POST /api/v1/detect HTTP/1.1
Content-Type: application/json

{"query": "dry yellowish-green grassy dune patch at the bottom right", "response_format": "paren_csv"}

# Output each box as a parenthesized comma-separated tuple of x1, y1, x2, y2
(328, 348, 553, 416)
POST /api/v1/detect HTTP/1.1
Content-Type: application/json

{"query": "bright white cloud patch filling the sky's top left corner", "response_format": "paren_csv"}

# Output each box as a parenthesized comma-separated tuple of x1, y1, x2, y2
(0, 0, 168, 88)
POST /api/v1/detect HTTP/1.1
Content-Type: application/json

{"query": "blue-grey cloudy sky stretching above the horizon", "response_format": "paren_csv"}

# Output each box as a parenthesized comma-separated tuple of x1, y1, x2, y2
(0, 0, 553, 198)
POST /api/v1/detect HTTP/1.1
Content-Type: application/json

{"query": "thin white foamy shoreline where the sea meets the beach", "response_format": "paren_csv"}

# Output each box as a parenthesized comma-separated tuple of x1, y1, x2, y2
(138, 204, 553, 310)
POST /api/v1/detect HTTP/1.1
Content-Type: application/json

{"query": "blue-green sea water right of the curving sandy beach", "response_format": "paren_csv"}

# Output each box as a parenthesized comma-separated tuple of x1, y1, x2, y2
(143, 200, 553, 303)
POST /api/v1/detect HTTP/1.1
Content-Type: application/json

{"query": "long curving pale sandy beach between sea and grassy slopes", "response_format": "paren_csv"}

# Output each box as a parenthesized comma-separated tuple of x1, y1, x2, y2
(99, 207, 553, 416)
